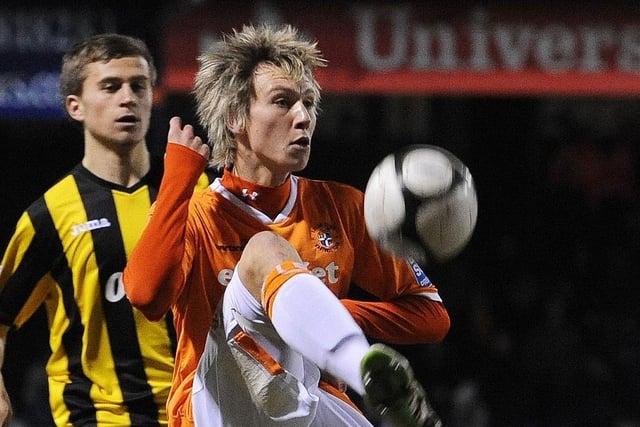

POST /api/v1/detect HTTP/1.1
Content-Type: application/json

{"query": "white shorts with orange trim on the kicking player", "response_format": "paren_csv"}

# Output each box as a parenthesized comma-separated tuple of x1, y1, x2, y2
(192, 266, 372, 427)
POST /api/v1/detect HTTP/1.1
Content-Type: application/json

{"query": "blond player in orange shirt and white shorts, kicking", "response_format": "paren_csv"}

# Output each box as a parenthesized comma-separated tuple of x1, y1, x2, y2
(123, 25, 449, 426)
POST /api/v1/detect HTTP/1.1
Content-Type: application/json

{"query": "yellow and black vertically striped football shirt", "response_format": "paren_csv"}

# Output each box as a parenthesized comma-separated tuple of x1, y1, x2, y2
(0, 159, 215, 426)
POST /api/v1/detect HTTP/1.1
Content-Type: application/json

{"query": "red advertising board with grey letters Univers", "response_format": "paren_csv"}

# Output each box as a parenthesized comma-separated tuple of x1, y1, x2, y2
(163, 1, 640, 97)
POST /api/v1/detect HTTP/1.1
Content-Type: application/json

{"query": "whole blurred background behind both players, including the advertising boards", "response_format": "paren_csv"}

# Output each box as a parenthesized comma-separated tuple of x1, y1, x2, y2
(0, 0, 640, 427)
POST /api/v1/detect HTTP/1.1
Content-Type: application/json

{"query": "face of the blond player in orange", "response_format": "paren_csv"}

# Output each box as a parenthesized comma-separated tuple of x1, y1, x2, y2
(236, 65, 317, 185)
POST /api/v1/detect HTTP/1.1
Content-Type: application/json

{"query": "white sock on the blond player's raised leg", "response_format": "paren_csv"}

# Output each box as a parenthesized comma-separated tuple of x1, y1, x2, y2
(271, 274, 369, 394)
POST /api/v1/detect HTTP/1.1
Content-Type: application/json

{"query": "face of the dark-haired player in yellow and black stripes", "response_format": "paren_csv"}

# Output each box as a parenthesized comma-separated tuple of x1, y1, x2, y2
(66, 57, 152, 149)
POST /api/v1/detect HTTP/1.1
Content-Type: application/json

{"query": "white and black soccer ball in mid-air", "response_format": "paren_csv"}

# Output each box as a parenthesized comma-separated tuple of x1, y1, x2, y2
(364, 145, 478, 264)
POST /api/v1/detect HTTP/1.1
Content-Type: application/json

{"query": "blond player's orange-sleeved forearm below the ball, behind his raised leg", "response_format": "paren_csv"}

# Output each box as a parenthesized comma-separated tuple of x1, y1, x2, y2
(342, 295, 450, 345)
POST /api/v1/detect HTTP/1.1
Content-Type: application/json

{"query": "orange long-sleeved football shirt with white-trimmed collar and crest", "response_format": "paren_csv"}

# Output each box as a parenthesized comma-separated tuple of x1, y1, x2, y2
(124, 143, 449, 426)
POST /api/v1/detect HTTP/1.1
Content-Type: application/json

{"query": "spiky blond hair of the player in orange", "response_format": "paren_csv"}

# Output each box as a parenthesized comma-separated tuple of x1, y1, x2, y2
(194, 24, 326, 168)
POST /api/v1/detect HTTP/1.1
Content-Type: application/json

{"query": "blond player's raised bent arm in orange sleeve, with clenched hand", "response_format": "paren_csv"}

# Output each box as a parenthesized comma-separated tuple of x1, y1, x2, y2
(122, 117, 209, 320)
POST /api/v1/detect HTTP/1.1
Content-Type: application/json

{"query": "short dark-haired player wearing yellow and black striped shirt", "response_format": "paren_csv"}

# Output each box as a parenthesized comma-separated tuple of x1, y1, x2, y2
(0, 34, 208, 426)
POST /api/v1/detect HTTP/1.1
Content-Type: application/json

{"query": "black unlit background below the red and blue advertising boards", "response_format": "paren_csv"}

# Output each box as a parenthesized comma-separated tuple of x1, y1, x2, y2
(0, 2, 640, 427)
